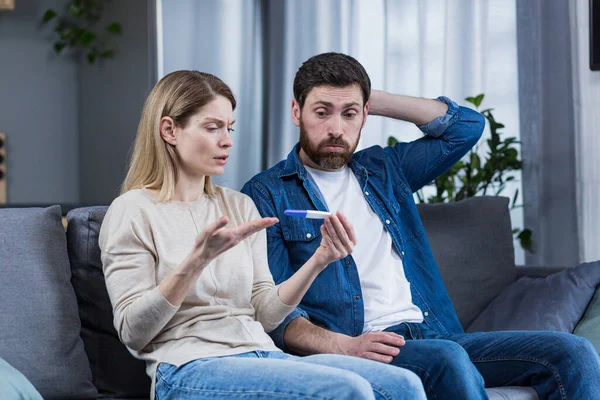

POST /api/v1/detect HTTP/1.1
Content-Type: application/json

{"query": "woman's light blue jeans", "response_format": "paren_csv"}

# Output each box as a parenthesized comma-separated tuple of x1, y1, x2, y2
(155, 351, 425, 400)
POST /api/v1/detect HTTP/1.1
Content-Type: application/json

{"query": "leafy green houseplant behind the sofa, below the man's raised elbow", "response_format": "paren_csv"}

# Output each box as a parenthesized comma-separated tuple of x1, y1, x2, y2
(388, 94, 533, 252)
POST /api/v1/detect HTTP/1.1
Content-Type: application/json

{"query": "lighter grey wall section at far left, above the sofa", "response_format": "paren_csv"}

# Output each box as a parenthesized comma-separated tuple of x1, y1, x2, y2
(0, 0, 80, 204)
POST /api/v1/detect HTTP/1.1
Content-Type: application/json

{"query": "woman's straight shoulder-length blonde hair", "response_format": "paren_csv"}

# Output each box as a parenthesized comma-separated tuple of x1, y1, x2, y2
(121, 71, 236, 202)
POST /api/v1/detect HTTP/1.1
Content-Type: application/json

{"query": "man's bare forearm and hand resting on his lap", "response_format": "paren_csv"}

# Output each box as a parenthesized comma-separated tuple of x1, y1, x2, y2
(284, 318, 404, 364)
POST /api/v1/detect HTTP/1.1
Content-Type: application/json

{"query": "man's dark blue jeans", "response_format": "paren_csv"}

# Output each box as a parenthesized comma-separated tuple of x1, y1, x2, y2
(386, 323, 600, 400)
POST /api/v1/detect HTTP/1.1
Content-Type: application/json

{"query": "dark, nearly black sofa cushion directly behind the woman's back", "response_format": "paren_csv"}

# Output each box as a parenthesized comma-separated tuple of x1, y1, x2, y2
(67, 206, 150, 397)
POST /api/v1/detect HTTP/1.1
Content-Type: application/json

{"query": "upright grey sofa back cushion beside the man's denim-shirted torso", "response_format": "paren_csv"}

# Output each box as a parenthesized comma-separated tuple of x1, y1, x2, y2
(417, 196, 517, 329)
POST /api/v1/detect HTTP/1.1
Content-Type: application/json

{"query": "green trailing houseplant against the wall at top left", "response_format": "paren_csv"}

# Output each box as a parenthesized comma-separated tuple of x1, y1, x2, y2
(42, 0, 121, 64)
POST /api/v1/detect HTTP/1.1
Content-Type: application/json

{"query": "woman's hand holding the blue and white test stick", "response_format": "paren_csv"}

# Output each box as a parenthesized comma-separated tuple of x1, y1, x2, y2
(315, 211, 356, 268)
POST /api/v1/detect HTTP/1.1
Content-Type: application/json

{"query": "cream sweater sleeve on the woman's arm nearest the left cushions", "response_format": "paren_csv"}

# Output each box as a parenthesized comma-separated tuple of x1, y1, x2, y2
(99, 195, 178, 351)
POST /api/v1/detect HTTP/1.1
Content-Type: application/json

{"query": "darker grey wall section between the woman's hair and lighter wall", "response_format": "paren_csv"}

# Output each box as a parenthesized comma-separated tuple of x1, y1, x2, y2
(79, 1, 156, 204)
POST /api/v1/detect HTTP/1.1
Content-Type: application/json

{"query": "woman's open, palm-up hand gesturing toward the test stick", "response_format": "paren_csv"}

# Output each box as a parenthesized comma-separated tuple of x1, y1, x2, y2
(185, 217, 279, 269)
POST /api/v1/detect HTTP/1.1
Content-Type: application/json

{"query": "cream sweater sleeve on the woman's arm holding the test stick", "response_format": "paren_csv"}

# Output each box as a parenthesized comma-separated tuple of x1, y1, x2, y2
(247, 198, 297, 333)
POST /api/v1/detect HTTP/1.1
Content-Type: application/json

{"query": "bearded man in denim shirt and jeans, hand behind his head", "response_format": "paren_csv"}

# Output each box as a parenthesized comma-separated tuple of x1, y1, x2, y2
(242, 53, 600, 399)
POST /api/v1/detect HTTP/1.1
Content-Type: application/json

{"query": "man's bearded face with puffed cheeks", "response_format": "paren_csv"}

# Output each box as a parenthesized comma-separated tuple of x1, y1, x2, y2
(292, 85, 369, 171)
